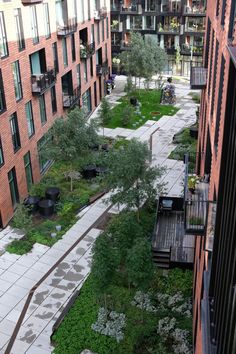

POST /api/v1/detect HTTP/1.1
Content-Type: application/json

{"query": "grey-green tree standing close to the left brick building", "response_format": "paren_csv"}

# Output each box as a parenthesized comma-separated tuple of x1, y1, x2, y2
(44, 108, 99, 164)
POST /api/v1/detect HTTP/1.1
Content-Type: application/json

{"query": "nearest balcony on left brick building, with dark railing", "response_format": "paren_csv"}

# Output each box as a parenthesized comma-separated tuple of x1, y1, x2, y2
(31, 68, 56, 95)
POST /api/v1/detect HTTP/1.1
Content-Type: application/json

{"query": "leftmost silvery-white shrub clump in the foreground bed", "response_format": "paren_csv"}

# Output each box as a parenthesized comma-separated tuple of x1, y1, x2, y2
(91, 307, 126, 342)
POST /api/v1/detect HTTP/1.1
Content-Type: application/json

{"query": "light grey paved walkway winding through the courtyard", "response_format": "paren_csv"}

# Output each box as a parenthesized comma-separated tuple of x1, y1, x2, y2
(0, 77, 199, 354)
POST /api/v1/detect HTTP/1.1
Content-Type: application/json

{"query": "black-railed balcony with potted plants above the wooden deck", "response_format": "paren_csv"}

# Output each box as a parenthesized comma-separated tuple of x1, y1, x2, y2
(184, 154, 209, 235)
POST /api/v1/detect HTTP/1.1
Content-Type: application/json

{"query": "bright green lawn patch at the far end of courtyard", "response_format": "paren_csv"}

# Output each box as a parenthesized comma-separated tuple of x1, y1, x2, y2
(106, 90, 178, 129)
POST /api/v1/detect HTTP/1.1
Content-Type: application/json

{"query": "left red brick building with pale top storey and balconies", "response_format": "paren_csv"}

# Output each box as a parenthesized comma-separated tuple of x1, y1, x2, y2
(0, 0, 111, 228)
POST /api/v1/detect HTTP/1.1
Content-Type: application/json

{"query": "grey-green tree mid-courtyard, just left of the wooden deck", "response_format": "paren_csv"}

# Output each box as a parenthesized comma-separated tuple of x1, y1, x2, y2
(106, 139, 164, 221)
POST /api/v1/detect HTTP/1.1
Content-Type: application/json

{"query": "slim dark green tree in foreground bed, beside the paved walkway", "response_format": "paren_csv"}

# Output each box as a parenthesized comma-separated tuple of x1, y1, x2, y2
(91, 233, 118, 307)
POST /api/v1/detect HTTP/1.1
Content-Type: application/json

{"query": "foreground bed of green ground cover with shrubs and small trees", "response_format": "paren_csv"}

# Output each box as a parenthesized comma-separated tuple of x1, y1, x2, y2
(53, 207, 192, 354)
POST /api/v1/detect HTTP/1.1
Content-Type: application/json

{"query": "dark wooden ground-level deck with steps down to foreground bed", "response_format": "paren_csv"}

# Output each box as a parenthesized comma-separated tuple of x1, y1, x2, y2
(152, 196, 195, 268)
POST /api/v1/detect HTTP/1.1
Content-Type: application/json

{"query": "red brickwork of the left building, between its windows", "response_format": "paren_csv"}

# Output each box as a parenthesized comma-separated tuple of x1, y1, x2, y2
(0, 14, 111, 226)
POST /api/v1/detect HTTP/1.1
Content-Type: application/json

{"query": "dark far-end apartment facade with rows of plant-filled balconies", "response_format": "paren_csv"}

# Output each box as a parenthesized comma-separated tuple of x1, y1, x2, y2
(111, 0, 206, 76)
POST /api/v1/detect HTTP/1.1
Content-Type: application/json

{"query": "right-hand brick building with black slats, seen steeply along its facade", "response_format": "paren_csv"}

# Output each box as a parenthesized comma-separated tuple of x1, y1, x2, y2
(191, 0, 236, 354)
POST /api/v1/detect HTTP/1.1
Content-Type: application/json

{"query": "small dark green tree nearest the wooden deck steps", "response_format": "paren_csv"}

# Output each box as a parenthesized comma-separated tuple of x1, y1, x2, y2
(127, 239, 154, 291)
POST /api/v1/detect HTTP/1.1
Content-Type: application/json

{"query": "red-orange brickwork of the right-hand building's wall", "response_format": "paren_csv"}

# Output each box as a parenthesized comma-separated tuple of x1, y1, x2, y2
(193, 0, 236, 354)
